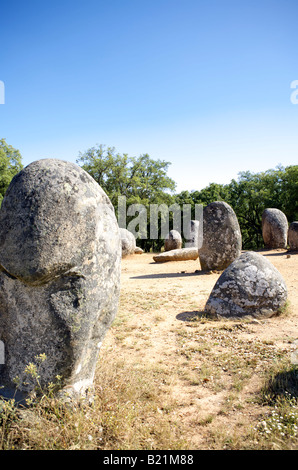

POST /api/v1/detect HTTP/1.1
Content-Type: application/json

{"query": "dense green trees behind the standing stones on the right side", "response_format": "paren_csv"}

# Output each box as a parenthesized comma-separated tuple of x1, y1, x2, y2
(176, 165, 298, 249)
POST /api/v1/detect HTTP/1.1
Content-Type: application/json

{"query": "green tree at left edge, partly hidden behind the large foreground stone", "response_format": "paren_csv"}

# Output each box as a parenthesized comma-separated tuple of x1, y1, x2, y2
(0, 139, 23, 203)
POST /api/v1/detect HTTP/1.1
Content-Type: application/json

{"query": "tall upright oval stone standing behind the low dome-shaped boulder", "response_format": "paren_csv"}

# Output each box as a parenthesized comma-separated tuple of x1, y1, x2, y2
(199, 201, 242, 271)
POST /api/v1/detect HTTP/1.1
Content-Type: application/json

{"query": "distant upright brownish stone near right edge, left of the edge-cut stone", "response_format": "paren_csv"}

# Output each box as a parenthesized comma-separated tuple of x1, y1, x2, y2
(262, 208, 288, 249)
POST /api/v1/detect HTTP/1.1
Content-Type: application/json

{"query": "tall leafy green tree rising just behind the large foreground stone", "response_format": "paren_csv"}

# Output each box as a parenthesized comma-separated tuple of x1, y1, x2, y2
(77, 145, 176, 251)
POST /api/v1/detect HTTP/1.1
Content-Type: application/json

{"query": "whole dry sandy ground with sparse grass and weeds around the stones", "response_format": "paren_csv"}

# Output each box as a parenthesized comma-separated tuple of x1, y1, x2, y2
(0, 250, 298, 450)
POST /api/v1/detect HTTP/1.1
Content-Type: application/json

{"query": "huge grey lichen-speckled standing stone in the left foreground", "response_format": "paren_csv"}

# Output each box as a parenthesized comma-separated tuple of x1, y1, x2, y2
(0, 159, 121, 402)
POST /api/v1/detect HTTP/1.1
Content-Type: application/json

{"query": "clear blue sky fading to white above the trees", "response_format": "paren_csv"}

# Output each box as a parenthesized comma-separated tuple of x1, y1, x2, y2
(0, 0, 298, 191)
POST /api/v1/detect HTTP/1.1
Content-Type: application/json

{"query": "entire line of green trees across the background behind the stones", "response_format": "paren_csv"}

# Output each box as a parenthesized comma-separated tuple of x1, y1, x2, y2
(0, 139, 298, 251)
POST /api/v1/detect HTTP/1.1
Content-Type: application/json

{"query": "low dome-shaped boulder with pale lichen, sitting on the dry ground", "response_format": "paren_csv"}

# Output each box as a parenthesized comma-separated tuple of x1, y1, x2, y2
(205, 252, 287, 318)
